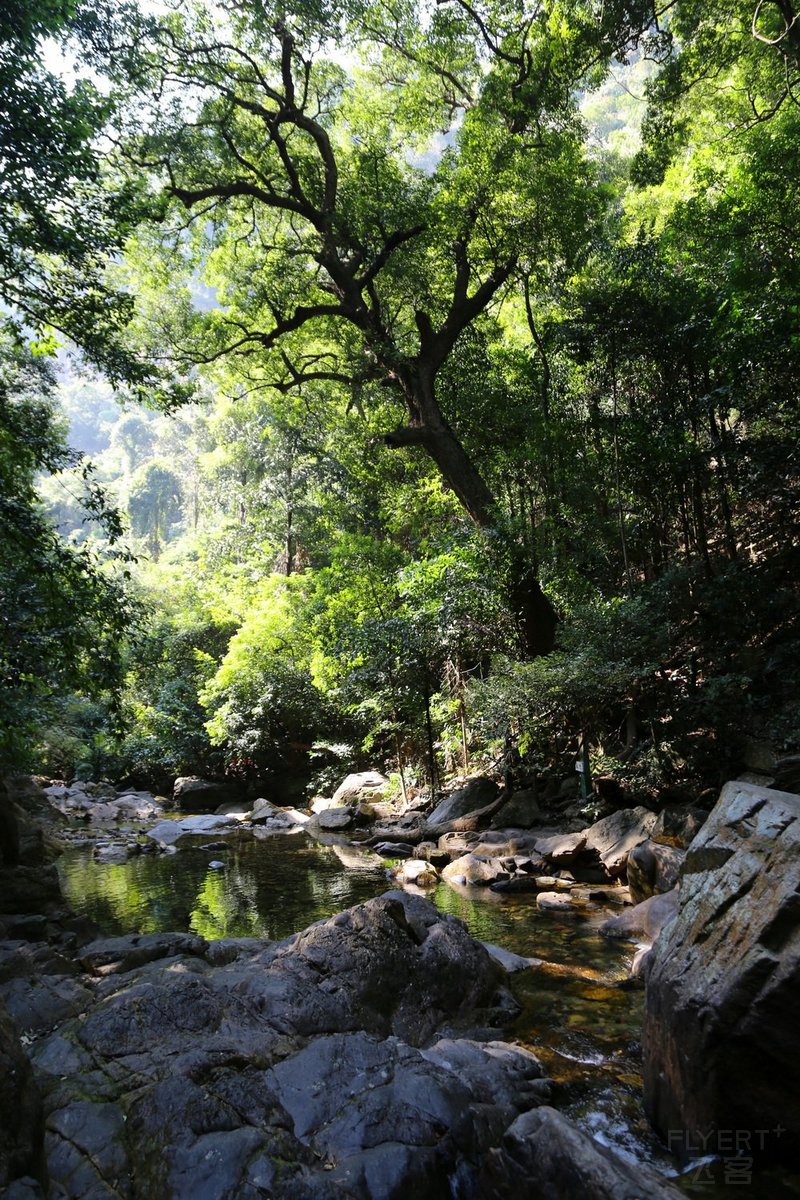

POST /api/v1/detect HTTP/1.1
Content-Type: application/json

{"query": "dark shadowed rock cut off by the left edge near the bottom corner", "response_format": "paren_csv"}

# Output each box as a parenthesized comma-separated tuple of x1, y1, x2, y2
(0, 1002, 47, 1194)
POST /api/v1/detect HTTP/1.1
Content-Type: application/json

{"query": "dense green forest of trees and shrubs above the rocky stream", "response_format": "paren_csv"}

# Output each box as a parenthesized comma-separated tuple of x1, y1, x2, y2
(0, 0, 800, 794)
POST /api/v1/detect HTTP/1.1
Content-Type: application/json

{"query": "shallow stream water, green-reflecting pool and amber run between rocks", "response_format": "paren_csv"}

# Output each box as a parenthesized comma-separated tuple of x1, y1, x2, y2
(59, 832, 800, 1200)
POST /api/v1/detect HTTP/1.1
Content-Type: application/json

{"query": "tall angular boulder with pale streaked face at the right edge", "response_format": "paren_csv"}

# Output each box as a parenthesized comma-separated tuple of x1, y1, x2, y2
(644, 781, 800, 1160)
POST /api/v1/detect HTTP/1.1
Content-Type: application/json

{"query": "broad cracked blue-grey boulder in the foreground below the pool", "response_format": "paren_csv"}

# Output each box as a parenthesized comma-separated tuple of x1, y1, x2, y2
(32, 892, 549, 1200)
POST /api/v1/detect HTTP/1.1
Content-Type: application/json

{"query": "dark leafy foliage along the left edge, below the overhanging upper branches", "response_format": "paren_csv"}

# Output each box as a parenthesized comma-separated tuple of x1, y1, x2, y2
(0, 332, 136, 766)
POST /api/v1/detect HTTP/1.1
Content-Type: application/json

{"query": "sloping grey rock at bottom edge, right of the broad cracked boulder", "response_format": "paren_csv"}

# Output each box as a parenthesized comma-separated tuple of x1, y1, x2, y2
(475, 1106, 682, 1200)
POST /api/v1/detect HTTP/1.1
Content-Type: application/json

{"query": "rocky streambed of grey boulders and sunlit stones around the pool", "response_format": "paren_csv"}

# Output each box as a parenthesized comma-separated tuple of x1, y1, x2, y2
(0, 780, 800, 1200)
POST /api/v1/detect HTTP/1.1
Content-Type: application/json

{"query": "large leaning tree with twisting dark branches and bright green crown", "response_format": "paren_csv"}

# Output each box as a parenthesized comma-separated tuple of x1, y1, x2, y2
(117, 0, 652, 653)
